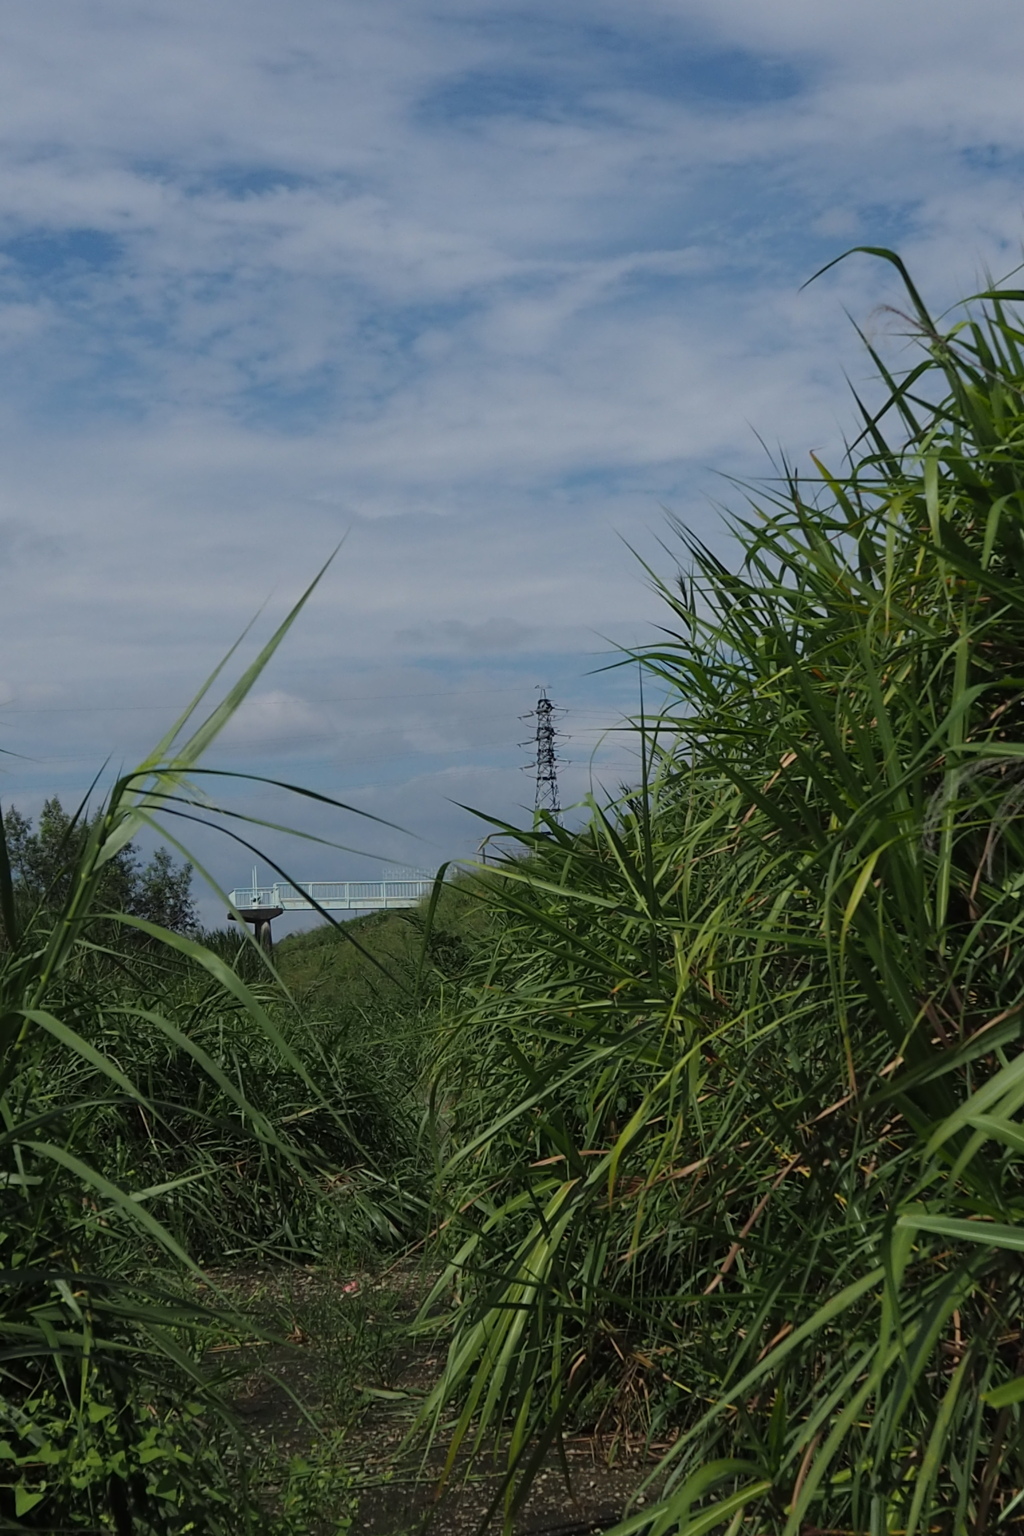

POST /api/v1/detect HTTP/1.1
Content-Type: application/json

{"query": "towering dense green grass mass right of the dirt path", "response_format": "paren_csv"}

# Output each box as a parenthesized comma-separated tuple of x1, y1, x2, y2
(424, 252, 1024, 1536)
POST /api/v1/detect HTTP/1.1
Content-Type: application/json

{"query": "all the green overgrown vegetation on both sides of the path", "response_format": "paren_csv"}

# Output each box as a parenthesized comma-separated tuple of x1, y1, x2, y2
(11, 252, 1024, 1536)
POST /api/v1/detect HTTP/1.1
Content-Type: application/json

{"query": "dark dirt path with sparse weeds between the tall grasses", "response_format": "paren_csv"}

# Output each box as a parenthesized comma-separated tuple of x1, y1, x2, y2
(221, 1267, 660, 1536)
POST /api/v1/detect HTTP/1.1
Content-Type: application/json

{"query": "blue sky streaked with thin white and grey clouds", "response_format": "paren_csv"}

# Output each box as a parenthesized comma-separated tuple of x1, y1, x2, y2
(0, 0, 1024, 920)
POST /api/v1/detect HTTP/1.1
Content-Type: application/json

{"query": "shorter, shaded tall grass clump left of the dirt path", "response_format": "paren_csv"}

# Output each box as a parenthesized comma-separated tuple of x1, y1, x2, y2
(0, 568, 405, 1536)
